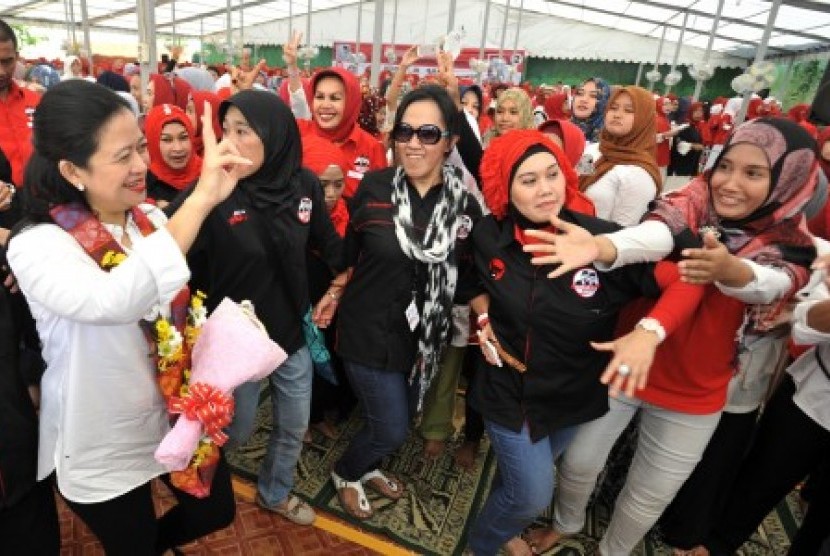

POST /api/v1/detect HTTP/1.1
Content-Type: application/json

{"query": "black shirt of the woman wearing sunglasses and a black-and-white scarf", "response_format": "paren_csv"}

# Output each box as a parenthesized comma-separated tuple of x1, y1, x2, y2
(337, 168, 481, 372)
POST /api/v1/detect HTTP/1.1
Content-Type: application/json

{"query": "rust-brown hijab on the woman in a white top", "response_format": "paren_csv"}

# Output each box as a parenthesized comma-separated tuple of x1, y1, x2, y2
(579, 87, 663, 191)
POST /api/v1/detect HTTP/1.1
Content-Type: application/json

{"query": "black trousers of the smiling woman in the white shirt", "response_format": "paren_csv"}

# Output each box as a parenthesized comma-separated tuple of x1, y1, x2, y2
(67, 457, 236, 556)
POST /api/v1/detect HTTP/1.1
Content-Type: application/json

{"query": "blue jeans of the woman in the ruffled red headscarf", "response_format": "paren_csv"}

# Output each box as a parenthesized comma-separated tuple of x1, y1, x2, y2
(468, 420, 576, 556)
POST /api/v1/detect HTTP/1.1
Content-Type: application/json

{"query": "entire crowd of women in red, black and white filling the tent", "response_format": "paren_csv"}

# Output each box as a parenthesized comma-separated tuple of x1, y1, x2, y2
(0, 16, 830, 556)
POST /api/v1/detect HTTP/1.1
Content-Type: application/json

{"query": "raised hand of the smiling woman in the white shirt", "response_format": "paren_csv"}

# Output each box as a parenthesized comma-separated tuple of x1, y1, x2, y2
(193, 102, 252, 206)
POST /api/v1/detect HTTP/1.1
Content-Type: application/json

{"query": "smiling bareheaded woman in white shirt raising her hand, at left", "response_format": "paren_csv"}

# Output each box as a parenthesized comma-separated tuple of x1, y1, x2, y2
(9, 80, 248, 554)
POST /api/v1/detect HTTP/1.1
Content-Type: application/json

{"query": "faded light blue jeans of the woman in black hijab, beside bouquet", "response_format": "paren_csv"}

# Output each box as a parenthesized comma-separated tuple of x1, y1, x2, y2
(227, 346, 313, 506)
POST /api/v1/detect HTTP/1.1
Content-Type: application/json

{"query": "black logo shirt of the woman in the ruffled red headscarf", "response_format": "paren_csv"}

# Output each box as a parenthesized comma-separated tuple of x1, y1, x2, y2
(472, 209, 660, 441)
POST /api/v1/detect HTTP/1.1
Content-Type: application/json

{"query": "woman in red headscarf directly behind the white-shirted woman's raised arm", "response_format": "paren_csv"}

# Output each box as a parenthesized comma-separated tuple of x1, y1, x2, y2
(144, 104, 202, 206)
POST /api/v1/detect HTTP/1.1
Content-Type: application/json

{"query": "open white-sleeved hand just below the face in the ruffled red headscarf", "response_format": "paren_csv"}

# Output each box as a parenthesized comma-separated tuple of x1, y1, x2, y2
(524, 215, 599, 278)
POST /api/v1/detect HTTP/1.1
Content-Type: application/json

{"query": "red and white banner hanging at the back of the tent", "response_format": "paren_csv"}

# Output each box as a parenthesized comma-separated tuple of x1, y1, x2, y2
(332, 41, 526, 85)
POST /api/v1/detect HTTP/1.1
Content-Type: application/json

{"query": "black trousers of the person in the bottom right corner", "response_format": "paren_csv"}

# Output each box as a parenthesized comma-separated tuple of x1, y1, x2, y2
(706, 375, 830, 556)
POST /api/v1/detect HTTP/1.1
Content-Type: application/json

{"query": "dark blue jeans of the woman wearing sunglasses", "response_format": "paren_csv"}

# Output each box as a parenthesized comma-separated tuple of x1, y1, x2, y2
(334, 361, 410, 482)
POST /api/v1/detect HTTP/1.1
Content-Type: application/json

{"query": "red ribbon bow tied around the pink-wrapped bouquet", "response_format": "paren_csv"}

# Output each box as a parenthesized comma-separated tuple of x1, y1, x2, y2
(167, 382, 234, 446)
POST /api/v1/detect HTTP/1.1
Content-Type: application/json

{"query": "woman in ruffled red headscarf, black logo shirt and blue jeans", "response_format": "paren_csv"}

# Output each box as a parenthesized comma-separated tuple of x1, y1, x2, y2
(469, 130, 692, 555)
